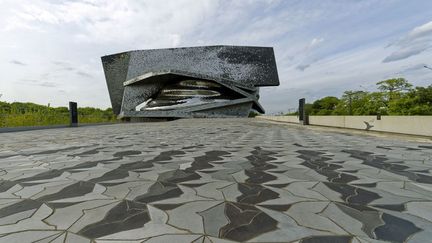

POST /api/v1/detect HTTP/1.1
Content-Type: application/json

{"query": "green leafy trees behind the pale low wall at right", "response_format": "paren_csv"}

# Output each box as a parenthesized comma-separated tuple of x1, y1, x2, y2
(294, 78, 432, 115)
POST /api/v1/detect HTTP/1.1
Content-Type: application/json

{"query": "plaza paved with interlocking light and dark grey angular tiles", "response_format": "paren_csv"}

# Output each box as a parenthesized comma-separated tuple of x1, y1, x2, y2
(0, 119, 432, 243)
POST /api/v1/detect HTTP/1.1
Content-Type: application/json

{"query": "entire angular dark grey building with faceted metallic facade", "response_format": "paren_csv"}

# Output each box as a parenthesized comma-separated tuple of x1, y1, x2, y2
(102, 46, 279, 118)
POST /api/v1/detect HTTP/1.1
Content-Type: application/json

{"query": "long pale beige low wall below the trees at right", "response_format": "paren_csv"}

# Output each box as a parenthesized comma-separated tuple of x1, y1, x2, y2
(258, 116, 432, 136)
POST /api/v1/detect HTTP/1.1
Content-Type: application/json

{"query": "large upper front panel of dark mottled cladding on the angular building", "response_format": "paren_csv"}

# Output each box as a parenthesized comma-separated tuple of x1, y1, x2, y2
(127, 46, 279, 87)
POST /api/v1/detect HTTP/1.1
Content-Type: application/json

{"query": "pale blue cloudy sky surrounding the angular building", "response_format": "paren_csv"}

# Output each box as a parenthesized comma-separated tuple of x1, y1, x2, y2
(0, 0, 432, 114)
